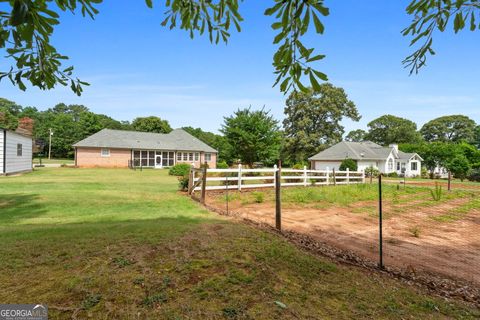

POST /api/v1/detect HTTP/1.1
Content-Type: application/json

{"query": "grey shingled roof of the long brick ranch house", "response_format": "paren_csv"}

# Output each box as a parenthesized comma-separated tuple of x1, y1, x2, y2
(73, 129, 217, 152)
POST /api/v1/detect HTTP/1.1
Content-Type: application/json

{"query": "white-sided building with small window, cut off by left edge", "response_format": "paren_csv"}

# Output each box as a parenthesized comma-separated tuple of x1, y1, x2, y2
(0, 128, 33, 175)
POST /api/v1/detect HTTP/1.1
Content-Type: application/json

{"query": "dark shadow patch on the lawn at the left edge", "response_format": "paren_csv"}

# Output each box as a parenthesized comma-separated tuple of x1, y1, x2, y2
(0, 194, 47, 225)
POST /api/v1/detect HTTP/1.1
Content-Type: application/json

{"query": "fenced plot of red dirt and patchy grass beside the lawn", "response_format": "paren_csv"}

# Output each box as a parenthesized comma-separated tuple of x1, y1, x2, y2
(198, 169, 480, 287)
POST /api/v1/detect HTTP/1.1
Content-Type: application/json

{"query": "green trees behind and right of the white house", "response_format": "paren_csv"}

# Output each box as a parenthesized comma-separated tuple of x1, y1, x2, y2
(345, 115, 480, 181)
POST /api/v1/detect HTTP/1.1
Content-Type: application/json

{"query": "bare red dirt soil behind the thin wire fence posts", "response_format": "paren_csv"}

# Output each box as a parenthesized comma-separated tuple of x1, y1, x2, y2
(207, 194, 480, 287)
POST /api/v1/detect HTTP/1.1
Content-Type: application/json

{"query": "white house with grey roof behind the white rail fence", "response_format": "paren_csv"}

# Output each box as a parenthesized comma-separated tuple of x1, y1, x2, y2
(308, 141, 423, 177)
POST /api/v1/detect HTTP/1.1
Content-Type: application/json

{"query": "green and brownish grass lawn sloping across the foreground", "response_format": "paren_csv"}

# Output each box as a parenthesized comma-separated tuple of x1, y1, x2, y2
(0, 168, 480, 319)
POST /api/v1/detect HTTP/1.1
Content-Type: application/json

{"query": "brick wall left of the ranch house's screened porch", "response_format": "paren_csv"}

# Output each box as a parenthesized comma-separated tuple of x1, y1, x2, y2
(76, 147, 132, 168)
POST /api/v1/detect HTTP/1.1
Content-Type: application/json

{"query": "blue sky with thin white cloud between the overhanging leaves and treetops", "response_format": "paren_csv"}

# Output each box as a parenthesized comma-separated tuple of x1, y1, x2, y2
(0, 0, 480, 132)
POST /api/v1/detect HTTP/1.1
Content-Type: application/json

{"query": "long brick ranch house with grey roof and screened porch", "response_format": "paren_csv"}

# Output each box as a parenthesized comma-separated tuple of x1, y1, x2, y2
(73, 129, 218, 169)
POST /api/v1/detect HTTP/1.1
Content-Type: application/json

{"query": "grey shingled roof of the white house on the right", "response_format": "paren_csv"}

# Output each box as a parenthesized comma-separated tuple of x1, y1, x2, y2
(308, 141, 423, 161)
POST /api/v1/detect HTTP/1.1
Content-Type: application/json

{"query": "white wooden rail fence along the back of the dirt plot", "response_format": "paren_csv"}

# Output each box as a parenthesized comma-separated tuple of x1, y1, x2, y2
(191, 165, 365, 191)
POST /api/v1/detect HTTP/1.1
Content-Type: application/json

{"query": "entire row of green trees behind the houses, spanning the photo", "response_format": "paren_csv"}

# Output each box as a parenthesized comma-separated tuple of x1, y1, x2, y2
(0, 83, 480, 178)
